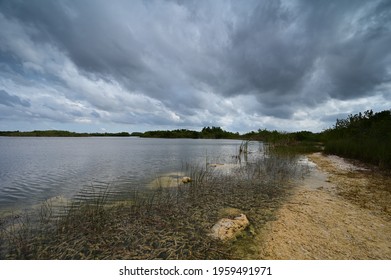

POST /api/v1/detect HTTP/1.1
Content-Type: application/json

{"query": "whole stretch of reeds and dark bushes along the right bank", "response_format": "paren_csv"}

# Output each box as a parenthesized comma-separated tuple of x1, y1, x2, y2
(242, 110, 391, 169)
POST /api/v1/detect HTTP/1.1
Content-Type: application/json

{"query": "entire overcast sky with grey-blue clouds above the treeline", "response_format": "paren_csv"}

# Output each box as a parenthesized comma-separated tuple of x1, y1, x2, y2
(0, 0, 391, 133)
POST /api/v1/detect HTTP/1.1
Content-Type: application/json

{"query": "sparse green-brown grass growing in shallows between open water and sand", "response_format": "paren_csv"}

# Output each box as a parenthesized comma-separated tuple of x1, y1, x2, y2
(0, 145, 308, 259)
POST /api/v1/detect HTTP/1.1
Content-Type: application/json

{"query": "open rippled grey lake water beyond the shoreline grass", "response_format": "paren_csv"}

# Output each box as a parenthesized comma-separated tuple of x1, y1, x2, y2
(0, 137, 262, 210)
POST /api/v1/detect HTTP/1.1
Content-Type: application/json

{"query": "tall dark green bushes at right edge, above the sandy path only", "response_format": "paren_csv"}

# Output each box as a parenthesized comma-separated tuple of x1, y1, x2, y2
(323, 110, 391, 169)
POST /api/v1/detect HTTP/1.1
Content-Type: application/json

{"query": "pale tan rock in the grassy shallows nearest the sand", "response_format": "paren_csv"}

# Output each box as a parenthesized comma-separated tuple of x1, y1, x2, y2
(210, 214, 250, 241)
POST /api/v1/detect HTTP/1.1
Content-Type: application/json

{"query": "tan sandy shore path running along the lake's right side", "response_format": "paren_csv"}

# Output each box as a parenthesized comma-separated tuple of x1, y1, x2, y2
(258, 153, 391, 260)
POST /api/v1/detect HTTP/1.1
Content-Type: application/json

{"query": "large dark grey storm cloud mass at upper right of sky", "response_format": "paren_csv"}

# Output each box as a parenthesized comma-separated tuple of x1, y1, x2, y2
(226, 1, 391, 110)
